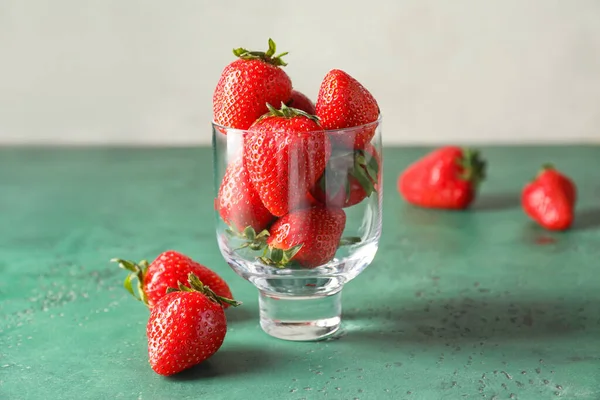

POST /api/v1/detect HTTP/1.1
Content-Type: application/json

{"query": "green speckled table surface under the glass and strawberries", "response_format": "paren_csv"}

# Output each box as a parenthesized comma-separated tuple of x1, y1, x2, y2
(0, 146, 600, 400)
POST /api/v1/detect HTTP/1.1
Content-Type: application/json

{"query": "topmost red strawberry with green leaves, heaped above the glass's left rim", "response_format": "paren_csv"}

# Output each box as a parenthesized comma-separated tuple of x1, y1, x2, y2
(213, 39, 292, 132)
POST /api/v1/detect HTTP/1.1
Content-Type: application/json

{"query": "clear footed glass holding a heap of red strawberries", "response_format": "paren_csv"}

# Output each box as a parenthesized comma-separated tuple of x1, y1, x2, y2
(213, 118, 383, 341)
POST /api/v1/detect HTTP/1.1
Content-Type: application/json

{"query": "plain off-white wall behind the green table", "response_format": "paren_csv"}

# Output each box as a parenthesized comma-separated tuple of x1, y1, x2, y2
(0, 0, 600, 145)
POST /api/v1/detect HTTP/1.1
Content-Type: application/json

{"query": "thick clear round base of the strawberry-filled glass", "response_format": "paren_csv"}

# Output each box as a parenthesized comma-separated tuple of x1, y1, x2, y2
(258, 290, 342, 341)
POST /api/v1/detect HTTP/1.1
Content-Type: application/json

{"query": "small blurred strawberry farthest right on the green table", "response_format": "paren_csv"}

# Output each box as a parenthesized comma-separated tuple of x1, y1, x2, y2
(521, 165, 577, 231)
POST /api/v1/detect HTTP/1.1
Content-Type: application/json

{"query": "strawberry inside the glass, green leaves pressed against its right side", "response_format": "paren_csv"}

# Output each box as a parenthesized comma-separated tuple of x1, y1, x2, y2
(312, 143, 380, 208)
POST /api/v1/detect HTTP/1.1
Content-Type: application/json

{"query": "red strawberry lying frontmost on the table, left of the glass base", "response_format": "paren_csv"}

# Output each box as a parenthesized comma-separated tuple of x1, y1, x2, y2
(146, 273, 239, 376)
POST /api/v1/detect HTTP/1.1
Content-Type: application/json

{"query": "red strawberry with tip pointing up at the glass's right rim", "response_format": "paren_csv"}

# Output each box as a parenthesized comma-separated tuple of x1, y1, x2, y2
(316, 69, 379, 149)
